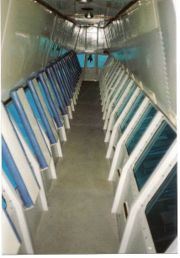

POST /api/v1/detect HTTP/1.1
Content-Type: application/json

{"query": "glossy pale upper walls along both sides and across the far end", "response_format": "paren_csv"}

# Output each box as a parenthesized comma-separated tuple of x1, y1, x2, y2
(1, 0, 176, 125)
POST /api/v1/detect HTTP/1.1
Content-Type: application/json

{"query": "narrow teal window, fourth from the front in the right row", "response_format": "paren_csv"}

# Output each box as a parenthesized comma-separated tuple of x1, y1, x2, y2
(120, 92, 144, 132)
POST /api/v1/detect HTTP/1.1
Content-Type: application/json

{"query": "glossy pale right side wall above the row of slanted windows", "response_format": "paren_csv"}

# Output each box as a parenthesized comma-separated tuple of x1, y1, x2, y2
(105, 0, 176, 122)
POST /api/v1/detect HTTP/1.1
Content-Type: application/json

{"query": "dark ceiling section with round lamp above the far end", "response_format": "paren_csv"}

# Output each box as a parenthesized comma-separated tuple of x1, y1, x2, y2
(43, 0, 132, 26)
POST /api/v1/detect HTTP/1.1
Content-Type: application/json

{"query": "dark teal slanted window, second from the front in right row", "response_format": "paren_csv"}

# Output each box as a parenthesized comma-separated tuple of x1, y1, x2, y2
(134, 121, 176, 190)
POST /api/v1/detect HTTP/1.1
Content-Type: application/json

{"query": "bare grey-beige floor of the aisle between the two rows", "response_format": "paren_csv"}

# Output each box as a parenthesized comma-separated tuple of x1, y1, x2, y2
(35, 82, 118, 254)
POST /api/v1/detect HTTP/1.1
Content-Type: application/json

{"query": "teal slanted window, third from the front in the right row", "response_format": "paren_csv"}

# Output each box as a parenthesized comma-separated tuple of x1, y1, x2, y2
(126, 105, 157, 155)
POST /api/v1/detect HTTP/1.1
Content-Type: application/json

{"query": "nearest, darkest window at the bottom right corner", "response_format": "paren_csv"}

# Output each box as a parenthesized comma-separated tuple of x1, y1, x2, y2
(145, 165, 177, 253)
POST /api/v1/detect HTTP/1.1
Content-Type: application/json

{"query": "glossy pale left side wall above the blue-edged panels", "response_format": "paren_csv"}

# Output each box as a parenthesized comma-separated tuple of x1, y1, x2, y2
(1, 0, 69, 100)
